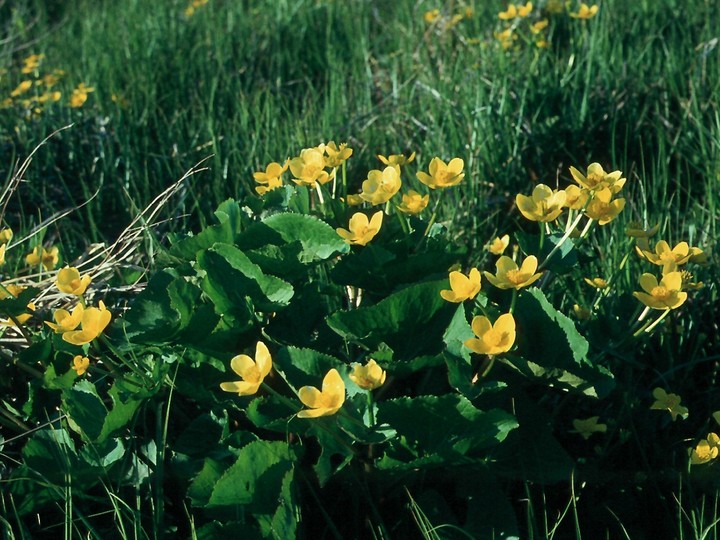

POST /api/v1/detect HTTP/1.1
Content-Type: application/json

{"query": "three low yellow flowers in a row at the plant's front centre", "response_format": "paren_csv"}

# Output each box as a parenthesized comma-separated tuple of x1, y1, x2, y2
(220, 341, 387, 418)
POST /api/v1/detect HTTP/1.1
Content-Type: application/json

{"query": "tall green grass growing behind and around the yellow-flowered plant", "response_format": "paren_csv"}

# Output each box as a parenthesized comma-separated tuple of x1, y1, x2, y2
(0, 0, 720, 538)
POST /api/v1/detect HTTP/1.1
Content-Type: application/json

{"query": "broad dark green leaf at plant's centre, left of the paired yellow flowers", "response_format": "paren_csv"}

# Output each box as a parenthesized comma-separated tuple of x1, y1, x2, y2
(328, 280, 456, 359)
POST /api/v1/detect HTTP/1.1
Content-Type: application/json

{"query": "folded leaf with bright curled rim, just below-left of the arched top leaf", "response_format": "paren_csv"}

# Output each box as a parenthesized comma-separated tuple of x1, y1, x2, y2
(198, 244, 294, 313)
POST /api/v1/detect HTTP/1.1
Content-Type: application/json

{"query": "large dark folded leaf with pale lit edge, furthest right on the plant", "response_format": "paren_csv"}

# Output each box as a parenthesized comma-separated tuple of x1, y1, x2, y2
(505, 288, 614, 397)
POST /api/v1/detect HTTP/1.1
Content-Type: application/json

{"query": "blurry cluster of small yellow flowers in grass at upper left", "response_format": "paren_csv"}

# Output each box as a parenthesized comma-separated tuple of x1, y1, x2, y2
(0, 54, 94, 116)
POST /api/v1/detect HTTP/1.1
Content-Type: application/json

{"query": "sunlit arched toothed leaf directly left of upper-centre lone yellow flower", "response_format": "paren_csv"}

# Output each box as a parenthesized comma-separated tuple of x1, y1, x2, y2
(237, 212, 350, 263)
